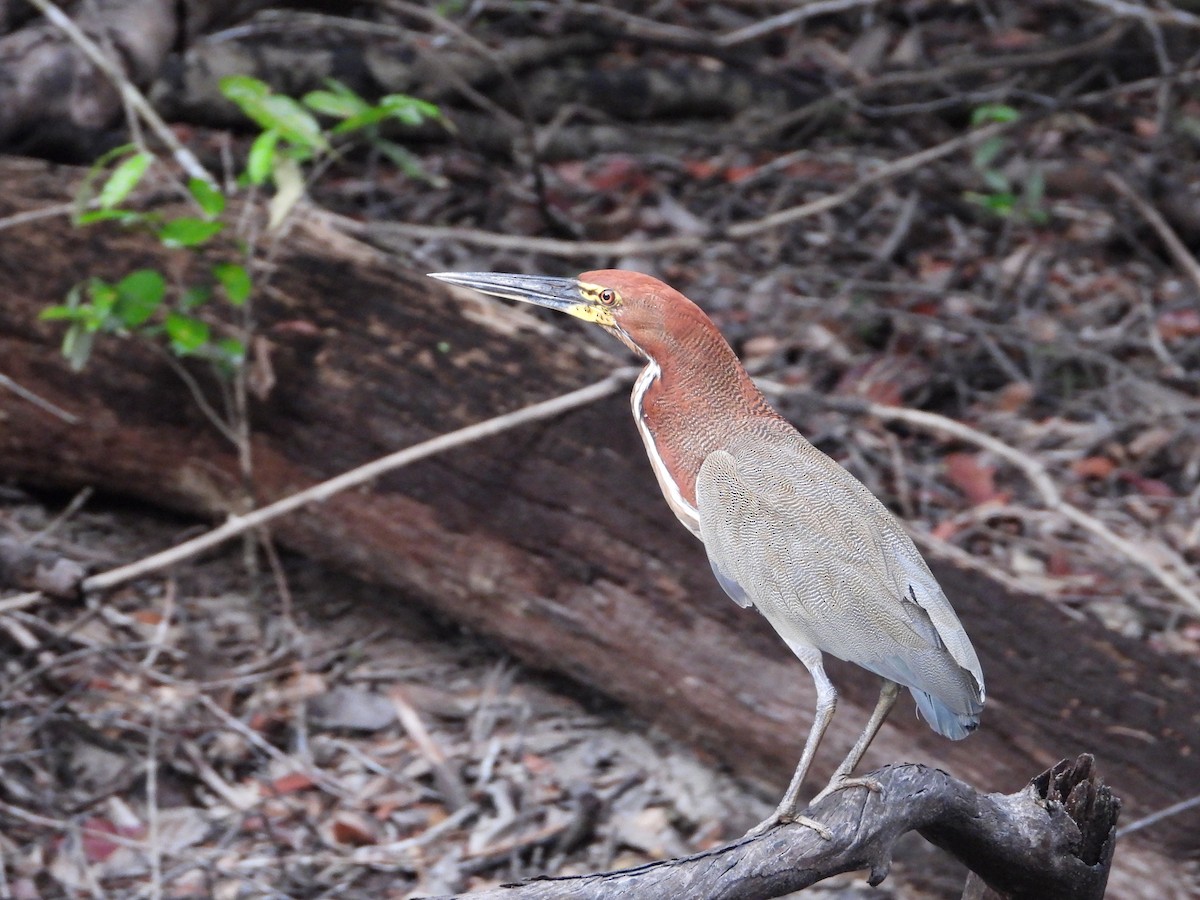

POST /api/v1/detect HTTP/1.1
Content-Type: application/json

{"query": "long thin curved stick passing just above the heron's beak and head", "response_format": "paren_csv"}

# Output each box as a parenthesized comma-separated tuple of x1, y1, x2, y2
(364, 120, 1020, 258)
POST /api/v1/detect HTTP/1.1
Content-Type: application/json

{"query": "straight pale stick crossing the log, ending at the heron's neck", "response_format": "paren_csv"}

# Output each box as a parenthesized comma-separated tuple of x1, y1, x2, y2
(79, 367, 637, 592)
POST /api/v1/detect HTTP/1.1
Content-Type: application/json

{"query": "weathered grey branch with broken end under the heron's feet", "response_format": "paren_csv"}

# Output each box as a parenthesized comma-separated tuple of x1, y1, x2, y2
(439, 755, 1121, 900)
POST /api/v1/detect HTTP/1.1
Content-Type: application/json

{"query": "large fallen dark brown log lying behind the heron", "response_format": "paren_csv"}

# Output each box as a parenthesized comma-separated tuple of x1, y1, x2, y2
(0, 154, 1200, 898)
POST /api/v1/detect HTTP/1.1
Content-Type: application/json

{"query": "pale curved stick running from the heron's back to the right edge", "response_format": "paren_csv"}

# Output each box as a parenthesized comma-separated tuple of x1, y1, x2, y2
(758, 379, 1200, 614)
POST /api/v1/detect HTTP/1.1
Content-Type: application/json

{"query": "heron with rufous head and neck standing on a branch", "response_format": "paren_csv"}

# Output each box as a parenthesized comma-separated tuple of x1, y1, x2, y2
(432, 269, 984, 838)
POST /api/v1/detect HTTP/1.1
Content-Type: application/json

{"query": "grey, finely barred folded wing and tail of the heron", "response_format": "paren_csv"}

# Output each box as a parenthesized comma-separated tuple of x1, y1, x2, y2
(696, 434, 984, 738)
